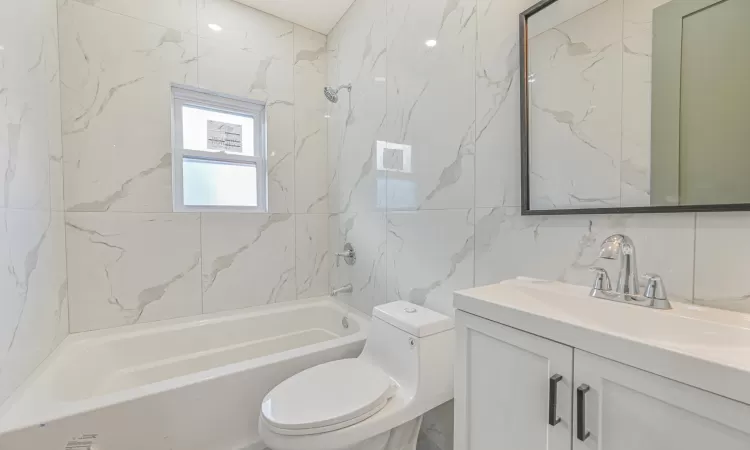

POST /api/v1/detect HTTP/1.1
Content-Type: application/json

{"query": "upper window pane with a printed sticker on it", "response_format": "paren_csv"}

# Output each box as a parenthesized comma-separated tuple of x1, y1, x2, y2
(182, 106, 255, 155)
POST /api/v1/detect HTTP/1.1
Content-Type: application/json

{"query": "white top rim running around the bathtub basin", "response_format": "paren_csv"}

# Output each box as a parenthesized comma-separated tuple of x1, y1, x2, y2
(0, 297, 370, 436)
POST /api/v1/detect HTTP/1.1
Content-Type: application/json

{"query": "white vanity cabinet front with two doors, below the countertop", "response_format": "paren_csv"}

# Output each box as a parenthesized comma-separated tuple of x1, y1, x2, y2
(455, 311, 750, 450)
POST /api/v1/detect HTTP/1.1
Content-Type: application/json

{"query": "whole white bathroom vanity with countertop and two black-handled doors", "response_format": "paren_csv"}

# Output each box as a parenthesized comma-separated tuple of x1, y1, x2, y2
(455, 279, 750, 450)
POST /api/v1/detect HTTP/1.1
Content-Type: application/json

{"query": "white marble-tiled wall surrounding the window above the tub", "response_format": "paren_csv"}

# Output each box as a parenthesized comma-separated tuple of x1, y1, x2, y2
(59, 0, 329, 332)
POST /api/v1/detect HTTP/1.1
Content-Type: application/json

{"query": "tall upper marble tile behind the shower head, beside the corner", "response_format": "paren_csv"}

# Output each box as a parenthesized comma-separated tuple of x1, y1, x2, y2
(327, 0, 386, 213)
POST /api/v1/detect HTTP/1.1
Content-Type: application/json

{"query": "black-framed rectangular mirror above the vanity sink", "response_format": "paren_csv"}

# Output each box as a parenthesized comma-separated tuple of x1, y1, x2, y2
(520, 0, 750, 214)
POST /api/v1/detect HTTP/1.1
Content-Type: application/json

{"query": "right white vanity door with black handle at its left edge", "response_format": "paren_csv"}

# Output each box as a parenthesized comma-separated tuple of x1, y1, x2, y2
(573, 350, 750, 450)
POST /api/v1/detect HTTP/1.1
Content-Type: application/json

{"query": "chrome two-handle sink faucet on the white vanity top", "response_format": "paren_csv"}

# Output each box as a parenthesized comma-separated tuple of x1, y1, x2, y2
(590, 234, 672, 309)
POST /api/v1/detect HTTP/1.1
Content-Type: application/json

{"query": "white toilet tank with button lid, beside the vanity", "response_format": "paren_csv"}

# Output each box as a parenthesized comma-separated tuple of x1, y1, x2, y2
(361, 301, 455, 406)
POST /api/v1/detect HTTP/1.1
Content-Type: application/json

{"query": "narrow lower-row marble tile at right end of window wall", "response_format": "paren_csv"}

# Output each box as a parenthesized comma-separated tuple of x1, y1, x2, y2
(295, 214, 331, 298)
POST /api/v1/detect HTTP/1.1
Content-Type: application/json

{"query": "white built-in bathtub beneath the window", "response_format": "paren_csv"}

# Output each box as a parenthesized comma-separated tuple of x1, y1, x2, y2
(0, 297, 369, 450)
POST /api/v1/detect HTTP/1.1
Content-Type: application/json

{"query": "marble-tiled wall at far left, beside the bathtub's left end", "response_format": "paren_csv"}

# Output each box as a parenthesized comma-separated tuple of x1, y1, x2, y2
(0, 0, 68, 404)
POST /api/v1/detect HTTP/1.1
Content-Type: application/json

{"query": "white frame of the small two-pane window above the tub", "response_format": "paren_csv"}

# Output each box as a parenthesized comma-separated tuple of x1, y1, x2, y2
(172, 84, 268, 212)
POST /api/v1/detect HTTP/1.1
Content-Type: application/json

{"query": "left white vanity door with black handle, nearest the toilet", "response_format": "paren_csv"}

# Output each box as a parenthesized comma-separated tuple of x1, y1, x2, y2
(455, 311, 573, 450)
